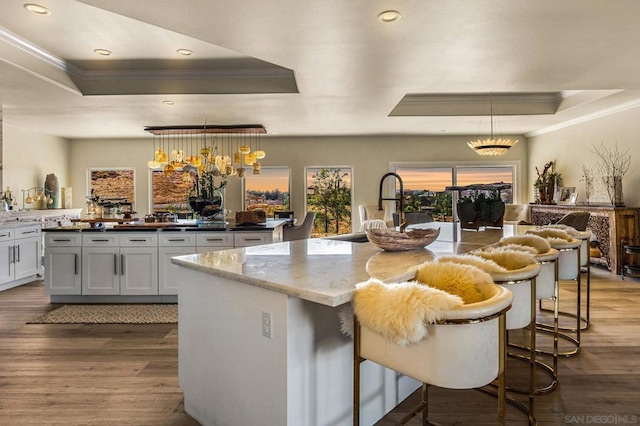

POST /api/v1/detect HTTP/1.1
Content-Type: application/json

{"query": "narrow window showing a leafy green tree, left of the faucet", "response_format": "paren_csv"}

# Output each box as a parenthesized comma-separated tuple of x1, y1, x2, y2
(306, 167, 352, 236)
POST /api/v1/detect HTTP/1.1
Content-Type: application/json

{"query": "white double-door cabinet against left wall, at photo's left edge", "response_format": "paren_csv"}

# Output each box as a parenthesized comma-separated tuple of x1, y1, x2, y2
(0, 224, 42, 289)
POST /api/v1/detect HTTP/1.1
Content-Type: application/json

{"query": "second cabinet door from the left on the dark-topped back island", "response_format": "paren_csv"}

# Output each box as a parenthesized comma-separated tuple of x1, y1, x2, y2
(82, 247, 120, 294)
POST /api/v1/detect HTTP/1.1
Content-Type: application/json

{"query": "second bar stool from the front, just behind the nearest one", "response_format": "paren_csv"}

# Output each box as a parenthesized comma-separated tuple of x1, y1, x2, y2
(438, 249, 540, 425)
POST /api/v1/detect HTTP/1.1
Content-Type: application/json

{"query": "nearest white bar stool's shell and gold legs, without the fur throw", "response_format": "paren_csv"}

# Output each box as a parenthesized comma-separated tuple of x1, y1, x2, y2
(353, 265, 513, 426)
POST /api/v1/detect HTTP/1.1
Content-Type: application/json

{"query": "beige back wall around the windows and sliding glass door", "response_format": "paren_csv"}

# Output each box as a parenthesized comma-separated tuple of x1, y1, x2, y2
(71, 136, 528, 227)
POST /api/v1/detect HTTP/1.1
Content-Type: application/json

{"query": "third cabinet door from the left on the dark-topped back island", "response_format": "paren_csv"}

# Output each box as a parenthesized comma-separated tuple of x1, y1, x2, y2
(120, 247, 158, 295)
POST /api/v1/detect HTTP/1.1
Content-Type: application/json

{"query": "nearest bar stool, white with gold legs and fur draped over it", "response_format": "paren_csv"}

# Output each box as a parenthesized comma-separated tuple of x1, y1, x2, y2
(353, 263, 513, 426)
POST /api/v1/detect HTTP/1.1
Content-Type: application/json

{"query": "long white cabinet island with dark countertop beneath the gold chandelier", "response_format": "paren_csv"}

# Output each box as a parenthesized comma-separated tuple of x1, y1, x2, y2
(44, 220, 287, 303)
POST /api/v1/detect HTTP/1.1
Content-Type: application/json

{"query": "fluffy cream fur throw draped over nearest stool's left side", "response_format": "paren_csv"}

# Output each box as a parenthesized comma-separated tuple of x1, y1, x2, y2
(353, 278, 462, 346)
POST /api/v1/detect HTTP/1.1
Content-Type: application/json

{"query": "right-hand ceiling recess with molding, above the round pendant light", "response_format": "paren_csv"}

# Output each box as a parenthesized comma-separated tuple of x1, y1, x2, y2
(389, 92, 562, 117)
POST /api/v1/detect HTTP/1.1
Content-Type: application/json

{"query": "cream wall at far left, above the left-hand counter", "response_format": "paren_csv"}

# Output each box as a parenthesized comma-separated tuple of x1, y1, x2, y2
(2, 124, 71, 208)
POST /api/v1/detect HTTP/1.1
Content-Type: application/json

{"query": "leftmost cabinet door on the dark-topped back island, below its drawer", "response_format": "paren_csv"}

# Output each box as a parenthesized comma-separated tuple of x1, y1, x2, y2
(44, 247, 82, 294)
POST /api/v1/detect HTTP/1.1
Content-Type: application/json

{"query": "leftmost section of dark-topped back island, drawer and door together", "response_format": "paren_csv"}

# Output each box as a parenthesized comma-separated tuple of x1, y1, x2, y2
(44, 232, 82, 294)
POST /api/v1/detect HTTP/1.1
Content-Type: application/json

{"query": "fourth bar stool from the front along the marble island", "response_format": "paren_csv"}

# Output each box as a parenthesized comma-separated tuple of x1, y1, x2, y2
(527, 229, 582, 357)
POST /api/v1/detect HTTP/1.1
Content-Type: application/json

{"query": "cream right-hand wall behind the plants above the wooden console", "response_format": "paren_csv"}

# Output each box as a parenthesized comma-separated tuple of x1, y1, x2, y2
(527, 108, 640, 207)
